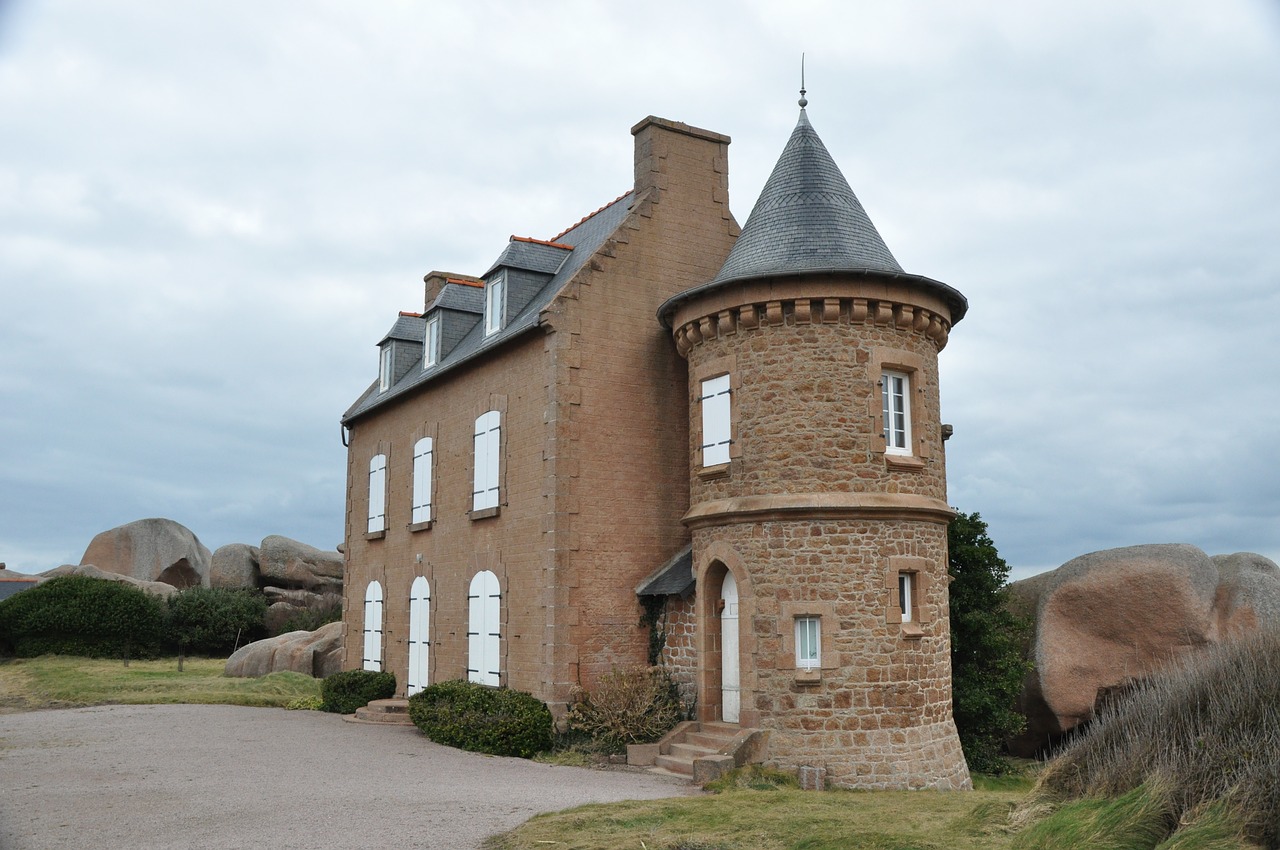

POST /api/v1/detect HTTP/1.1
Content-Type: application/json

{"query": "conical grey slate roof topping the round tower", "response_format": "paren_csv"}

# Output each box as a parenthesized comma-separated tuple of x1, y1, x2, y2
(658, 108, 969, 325)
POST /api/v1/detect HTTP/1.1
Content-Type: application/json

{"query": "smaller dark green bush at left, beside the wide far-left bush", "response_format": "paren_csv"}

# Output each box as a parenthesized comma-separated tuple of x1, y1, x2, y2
(169, 588, 266, 657)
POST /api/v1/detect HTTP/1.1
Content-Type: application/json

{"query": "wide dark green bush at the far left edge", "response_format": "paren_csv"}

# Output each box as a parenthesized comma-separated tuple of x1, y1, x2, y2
(0, 576, 165, 658)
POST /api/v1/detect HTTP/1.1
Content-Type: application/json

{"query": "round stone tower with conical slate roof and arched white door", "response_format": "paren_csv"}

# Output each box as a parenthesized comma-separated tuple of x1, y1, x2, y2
(659, 101, 969, 789)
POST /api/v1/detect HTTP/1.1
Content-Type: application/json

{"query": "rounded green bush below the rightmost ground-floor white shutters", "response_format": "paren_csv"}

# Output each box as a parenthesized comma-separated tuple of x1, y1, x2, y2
(408, 680, 552, 758)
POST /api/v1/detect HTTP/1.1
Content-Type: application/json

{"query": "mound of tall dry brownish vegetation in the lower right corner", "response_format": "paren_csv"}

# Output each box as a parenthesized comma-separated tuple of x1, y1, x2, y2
(1037, 629, 1280, 847)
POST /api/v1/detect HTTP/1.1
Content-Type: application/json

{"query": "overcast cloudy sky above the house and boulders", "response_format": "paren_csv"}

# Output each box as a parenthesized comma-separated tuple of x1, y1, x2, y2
(0, 0, 1280, 577)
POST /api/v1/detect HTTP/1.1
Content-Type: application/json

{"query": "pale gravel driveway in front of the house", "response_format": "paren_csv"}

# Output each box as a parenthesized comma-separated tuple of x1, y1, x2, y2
(0, 705, 696, 850)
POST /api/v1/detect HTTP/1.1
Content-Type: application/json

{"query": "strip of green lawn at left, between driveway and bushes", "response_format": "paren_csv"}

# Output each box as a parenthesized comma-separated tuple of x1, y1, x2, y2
(0, 655, 320, 713)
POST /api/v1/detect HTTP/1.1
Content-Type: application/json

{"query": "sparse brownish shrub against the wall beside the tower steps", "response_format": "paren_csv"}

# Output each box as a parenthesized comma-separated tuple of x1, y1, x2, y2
(568, 667, 685, 753)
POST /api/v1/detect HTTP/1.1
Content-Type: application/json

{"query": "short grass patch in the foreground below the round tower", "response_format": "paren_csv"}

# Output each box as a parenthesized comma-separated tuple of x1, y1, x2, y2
(486, 780, 1025, 850)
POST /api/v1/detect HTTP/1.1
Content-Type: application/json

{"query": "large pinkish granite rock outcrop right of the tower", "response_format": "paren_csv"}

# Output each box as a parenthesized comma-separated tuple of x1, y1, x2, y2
(1010, 544, 1280, 755)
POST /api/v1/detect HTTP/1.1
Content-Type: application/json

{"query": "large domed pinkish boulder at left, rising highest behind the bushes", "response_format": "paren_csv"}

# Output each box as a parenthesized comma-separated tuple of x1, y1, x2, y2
(81, 518, 212, 589)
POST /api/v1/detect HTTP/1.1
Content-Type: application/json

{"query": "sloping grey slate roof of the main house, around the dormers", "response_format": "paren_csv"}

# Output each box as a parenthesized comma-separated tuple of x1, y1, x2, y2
(342, 192, 632, 425)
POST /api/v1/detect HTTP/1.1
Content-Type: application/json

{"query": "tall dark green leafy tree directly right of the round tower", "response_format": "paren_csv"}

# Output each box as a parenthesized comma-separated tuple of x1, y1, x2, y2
(947, 513, 1029, 773)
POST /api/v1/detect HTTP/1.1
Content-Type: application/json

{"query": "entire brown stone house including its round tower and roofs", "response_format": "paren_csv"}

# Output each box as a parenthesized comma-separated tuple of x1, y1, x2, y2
(343, 100, 969, 787)
